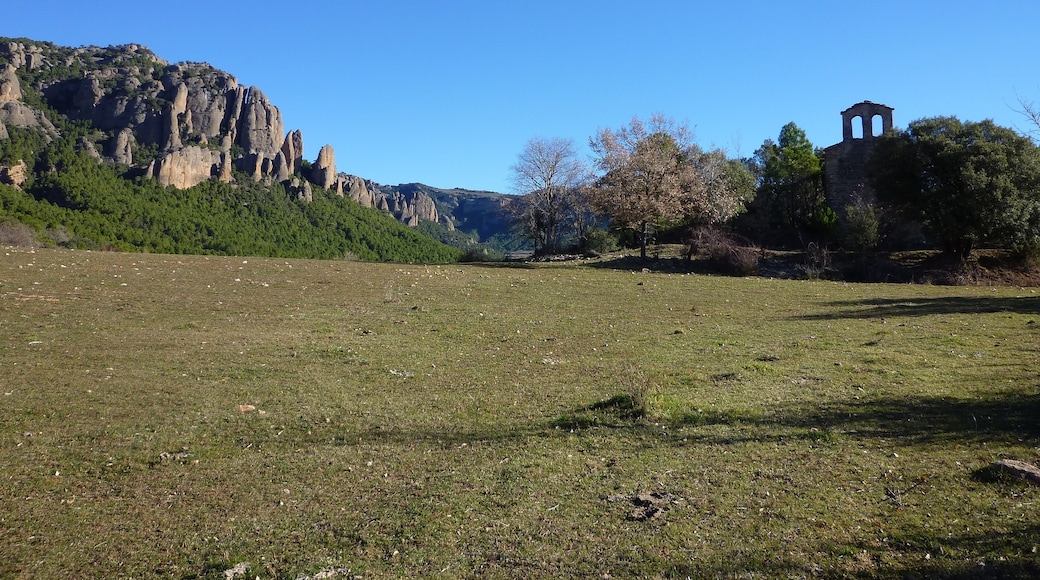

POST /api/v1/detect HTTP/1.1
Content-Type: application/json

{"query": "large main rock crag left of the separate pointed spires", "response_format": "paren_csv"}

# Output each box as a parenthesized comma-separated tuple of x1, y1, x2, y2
(6, 43, 289, 189)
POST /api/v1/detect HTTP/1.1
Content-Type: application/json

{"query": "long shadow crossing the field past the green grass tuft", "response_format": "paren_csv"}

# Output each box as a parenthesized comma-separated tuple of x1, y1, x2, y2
(237, 385, 1040, 448)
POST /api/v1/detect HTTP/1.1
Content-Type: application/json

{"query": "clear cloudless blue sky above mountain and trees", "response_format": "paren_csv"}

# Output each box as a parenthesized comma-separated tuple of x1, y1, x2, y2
(0, 0, 1040, 192)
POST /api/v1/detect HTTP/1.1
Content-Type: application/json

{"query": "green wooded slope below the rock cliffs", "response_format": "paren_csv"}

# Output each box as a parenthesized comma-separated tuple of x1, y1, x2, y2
(0, 129, 461, 262)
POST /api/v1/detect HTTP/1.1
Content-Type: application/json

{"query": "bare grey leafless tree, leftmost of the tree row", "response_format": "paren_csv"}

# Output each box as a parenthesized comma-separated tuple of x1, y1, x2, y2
(510, 137, 589, 254)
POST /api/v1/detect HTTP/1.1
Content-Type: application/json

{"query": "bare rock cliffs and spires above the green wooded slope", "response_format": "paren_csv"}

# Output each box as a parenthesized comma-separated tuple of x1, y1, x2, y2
(0, 39, 478, 228)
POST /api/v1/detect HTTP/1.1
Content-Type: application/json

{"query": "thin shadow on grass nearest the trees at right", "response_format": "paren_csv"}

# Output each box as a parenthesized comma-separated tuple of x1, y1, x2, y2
(798, 296, 1040, 320)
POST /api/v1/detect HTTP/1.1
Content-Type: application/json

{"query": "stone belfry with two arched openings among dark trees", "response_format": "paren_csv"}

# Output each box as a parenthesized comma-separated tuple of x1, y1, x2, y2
(824, 101, 894, 215)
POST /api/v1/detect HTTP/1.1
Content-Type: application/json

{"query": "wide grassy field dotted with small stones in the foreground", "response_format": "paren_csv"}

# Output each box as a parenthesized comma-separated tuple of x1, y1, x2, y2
(0, 248, 1040, 579)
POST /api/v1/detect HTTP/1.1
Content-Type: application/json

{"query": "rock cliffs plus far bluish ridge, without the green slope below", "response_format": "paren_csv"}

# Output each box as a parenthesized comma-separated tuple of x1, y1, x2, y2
(0, 37, 520, 258)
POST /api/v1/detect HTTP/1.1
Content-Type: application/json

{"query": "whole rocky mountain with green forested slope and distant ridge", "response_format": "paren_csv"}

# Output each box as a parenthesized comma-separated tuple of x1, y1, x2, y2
(0, 37, 520, 261)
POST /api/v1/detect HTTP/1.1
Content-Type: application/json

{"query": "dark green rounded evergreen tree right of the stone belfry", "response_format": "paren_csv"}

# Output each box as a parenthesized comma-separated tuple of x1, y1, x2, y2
(870, 116, 1040, 259)
